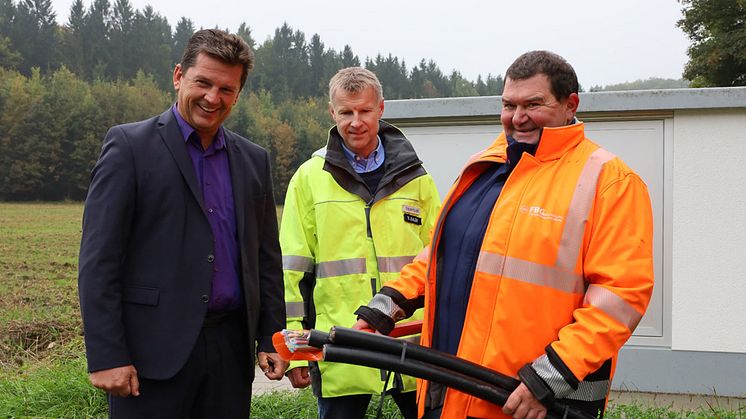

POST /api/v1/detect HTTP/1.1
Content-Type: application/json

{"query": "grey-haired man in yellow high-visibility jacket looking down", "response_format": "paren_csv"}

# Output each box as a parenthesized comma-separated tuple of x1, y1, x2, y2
(280, 67, 440, 419)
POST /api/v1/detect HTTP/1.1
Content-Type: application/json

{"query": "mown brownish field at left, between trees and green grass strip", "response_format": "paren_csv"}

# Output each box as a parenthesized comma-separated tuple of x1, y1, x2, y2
(0, 203, 83, 376)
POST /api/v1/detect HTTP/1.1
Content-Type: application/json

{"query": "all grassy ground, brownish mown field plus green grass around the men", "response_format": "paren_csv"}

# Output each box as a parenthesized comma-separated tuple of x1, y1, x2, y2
(0, 202, 746, 419)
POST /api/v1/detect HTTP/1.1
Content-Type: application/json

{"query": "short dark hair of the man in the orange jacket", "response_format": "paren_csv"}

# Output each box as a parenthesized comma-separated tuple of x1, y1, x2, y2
(505, 51, 580, 100)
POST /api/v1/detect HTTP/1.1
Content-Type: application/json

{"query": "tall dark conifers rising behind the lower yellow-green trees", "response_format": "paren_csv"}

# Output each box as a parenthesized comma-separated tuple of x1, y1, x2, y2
(0, 0, 503, 101)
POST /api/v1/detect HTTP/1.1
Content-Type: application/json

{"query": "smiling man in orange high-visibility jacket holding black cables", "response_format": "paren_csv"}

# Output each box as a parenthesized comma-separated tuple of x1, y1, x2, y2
(355, 51, 653, 419)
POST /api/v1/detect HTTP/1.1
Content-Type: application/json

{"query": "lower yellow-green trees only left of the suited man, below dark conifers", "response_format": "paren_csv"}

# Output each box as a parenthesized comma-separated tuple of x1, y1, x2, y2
(0, 68, 170, 200)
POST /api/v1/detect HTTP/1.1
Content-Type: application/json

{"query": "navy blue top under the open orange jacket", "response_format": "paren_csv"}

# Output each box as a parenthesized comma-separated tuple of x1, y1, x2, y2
(433, 138, 537, 355)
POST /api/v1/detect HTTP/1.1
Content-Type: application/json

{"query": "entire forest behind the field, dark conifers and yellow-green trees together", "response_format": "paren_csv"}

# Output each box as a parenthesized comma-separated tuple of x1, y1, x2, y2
(0, 0, 684, 202)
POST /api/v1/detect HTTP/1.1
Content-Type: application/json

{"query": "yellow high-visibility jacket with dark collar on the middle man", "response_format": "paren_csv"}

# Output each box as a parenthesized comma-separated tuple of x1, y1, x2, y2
(280, 122, 440, 397)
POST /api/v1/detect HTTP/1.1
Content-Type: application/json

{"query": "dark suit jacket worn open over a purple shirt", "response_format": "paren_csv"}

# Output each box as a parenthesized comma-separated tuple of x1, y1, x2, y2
(78, 109, 285, 379)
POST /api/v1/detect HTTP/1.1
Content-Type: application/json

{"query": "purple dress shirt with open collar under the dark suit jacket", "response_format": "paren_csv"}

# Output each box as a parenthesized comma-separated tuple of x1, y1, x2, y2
(171, 105, 243, 311)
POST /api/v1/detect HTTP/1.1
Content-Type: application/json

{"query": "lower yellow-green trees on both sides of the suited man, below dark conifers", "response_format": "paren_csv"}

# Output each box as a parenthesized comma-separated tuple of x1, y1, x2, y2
(0, 68, 331, 202)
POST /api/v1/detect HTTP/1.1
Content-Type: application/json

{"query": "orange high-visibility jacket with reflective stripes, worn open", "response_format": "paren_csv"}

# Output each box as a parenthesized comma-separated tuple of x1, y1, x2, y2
(378, 123, 653, 419)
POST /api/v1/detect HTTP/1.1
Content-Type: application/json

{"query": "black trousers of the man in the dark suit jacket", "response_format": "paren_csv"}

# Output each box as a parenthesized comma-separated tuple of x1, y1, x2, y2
(109, 315, 254, 419)
